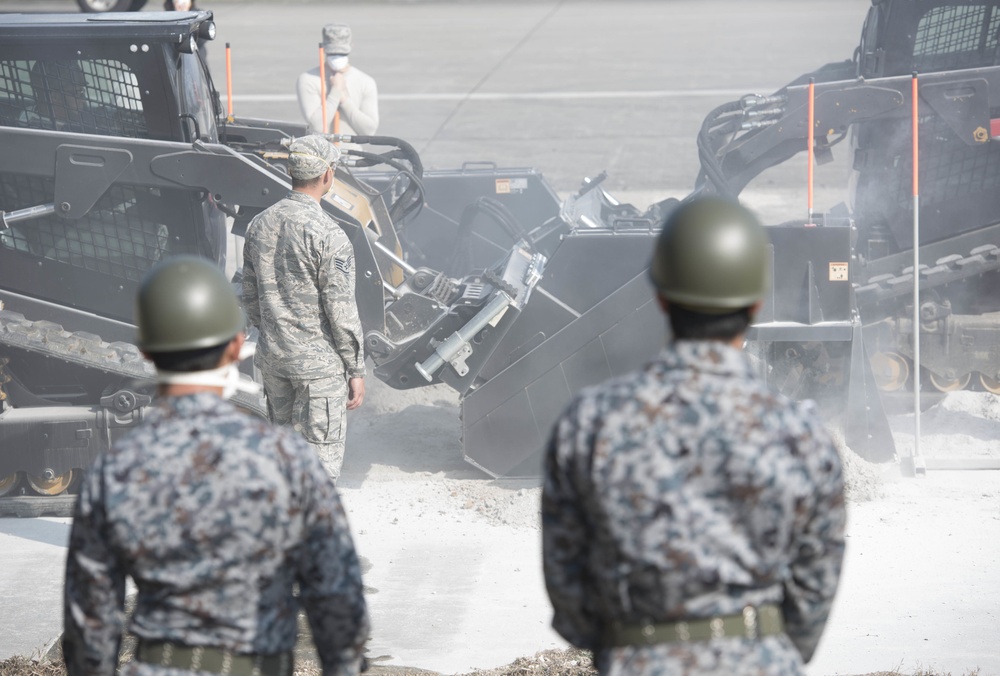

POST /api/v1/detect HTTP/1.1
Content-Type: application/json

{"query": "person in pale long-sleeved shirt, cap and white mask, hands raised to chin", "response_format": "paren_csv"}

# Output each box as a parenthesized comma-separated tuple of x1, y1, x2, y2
(295, 23, 378, 136)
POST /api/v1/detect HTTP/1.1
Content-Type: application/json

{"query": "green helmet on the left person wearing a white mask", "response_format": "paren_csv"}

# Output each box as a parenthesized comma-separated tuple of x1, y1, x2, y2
(135, 256, 245, 354)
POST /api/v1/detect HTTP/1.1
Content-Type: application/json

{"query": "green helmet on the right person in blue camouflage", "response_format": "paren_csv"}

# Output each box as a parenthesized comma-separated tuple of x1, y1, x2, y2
(649, 197, 770, 314)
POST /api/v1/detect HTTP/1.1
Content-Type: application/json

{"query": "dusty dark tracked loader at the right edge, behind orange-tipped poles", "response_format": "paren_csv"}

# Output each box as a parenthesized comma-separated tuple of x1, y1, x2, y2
(695, 0, 1000, 461)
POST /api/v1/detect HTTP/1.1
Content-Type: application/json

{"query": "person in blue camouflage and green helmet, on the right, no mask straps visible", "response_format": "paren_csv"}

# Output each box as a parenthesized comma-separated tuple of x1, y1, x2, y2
(542, 198, 845, 675)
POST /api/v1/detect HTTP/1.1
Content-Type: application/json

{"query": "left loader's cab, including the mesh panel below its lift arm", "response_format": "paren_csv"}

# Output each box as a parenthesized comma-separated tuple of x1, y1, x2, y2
(0, 12, 225, 322)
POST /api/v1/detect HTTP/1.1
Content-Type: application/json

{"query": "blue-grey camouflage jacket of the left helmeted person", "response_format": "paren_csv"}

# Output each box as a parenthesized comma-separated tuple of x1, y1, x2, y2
(63, 394, 369, 676)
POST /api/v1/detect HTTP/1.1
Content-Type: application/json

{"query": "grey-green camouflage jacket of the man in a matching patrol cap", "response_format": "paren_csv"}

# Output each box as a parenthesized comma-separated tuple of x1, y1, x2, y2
(243, 192, 365, 380)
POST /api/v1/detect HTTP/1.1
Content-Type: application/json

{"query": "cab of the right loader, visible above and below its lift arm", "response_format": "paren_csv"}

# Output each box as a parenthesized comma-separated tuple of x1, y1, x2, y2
(852, 0, 1000, 260)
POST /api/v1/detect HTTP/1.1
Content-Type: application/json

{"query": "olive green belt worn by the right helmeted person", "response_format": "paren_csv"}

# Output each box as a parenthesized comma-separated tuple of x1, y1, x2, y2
(604, 605, 785, 648)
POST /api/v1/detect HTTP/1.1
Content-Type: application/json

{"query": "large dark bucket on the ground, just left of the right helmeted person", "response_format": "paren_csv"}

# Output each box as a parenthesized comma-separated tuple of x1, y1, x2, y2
(462, 227, 666, 477)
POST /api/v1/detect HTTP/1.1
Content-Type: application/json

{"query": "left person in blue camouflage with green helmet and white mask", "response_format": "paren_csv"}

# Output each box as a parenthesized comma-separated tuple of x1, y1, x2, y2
(63, 256, 369, 676)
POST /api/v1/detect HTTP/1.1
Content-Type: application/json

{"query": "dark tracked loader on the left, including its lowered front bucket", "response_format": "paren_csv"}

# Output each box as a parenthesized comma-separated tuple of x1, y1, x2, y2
(0, 12, 663, 513)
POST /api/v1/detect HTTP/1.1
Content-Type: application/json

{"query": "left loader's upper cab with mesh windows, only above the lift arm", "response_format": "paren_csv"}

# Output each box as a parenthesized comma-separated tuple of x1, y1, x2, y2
(0, 12, 220, 141)
